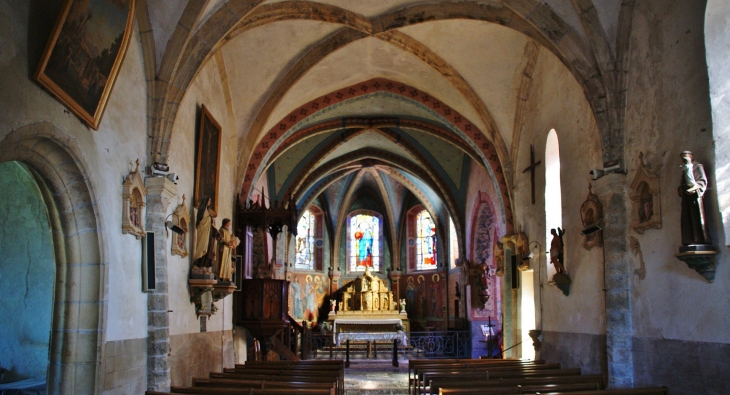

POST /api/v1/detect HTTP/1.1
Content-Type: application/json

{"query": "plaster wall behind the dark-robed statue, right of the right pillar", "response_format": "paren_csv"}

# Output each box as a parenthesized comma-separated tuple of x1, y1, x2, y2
(626, 0, 730, 343)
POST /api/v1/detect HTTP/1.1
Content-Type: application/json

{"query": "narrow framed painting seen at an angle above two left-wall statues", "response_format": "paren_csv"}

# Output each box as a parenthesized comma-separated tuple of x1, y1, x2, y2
(193, 106, 222, 212)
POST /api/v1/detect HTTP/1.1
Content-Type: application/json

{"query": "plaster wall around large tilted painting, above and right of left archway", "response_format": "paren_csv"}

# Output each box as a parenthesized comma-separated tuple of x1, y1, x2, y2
(0, 0, 147, 341)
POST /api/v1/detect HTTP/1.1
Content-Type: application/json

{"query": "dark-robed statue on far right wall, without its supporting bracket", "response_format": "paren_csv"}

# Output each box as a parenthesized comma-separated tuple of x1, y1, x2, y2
(677, 151, 712, 246)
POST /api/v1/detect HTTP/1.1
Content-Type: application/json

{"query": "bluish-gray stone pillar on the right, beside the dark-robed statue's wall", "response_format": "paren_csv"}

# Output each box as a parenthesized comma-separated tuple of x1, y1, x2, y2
(593, 173, 634, 388)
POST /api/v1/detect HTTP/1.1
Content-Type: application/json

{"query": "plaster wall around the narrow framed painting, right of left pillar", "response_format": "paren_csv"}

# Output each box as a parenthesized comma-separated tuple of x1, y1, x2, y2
(164, 55, 237, 338)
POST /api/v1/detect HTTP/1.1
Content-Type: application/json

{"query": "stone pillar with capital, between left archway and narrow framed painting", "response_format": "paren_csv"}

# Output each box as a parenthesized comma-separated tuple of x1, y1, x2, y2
(145, 177, 177, 392)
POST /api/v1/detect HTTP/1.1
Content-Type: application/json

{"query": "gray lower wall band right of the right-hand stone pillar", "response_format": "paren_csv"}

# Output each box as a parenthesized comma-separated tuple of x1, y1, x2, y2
(633, 337, 730, 395)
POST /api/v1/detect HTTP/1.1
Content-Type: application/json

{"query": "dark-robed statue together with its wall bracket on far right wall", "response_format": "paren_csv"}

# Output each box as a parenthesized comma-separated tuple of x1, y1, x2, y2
(675, 151, 717, 282)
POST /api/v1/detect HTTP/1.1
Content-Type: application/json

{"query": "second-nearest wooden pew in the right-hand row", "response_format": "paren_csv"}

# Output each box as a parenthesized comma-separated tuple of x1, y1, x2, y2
(429, 374, 605, 393)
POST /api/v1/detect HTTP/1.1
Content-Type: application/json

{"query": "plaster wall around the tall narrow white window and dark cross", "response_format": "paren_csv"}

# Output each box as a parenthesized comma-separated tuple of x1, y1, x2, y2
(513, 45, 605, 338)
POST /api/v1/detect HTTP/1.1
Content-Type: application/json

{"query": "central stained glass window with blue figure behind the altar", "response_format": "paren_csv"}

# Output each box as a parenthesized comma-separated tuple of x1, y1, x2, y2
(350, 214, 380, 272)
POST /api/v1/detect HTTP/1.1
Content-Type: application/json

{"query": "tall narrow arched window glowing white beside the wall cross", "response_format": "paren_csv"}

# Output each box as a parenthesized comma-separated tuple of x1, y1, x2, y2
(545, 129, 563, 276)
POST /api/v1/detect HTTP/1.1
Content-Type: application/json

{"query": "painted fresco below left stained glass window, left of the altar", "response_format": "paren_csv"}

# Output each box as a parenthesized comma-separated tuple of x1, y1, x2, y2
(287, 273, 329, 322)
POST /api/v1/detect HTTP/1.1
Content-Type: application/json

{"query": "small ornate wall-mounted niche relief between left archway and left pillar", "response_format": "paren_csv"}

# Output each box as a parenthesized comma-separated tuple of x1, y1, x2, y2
(122, 159, 147, 240)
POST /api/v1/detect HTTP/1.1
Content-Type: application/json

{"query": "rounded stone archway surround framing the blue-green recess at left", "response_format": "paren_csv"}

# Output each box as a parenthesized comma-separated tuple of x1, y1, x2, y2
(0, 122, 107, 394)
